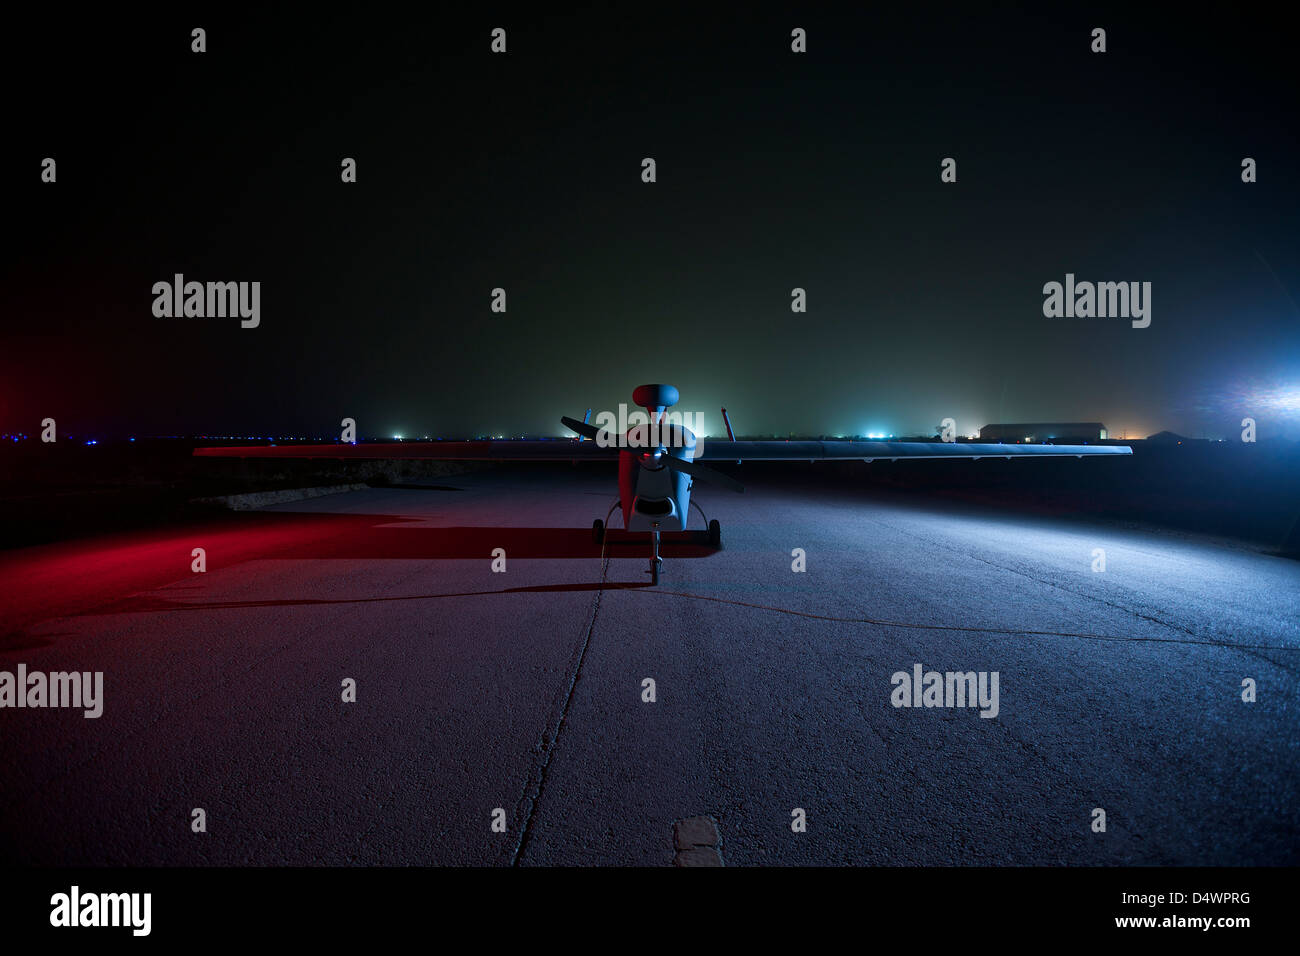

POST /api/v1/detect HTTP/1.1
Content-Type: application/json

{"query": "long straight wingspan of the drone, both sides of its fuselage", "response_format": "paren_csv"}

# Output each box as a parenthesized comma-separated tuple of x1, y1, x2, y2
(194, 438, 1132, 462)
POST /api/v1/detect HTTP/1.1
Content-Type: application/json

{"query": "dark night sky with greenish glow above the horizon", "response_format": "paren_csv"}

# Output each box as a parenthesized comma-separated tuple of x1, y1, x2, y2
(0, 4, 1300, 440)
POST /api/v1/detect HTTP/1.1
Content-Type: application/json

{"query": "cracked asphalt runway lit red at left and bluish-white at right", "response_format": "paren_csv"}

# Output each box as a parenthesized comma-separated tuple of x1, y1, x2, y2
(0, 468, 1300, 865)
